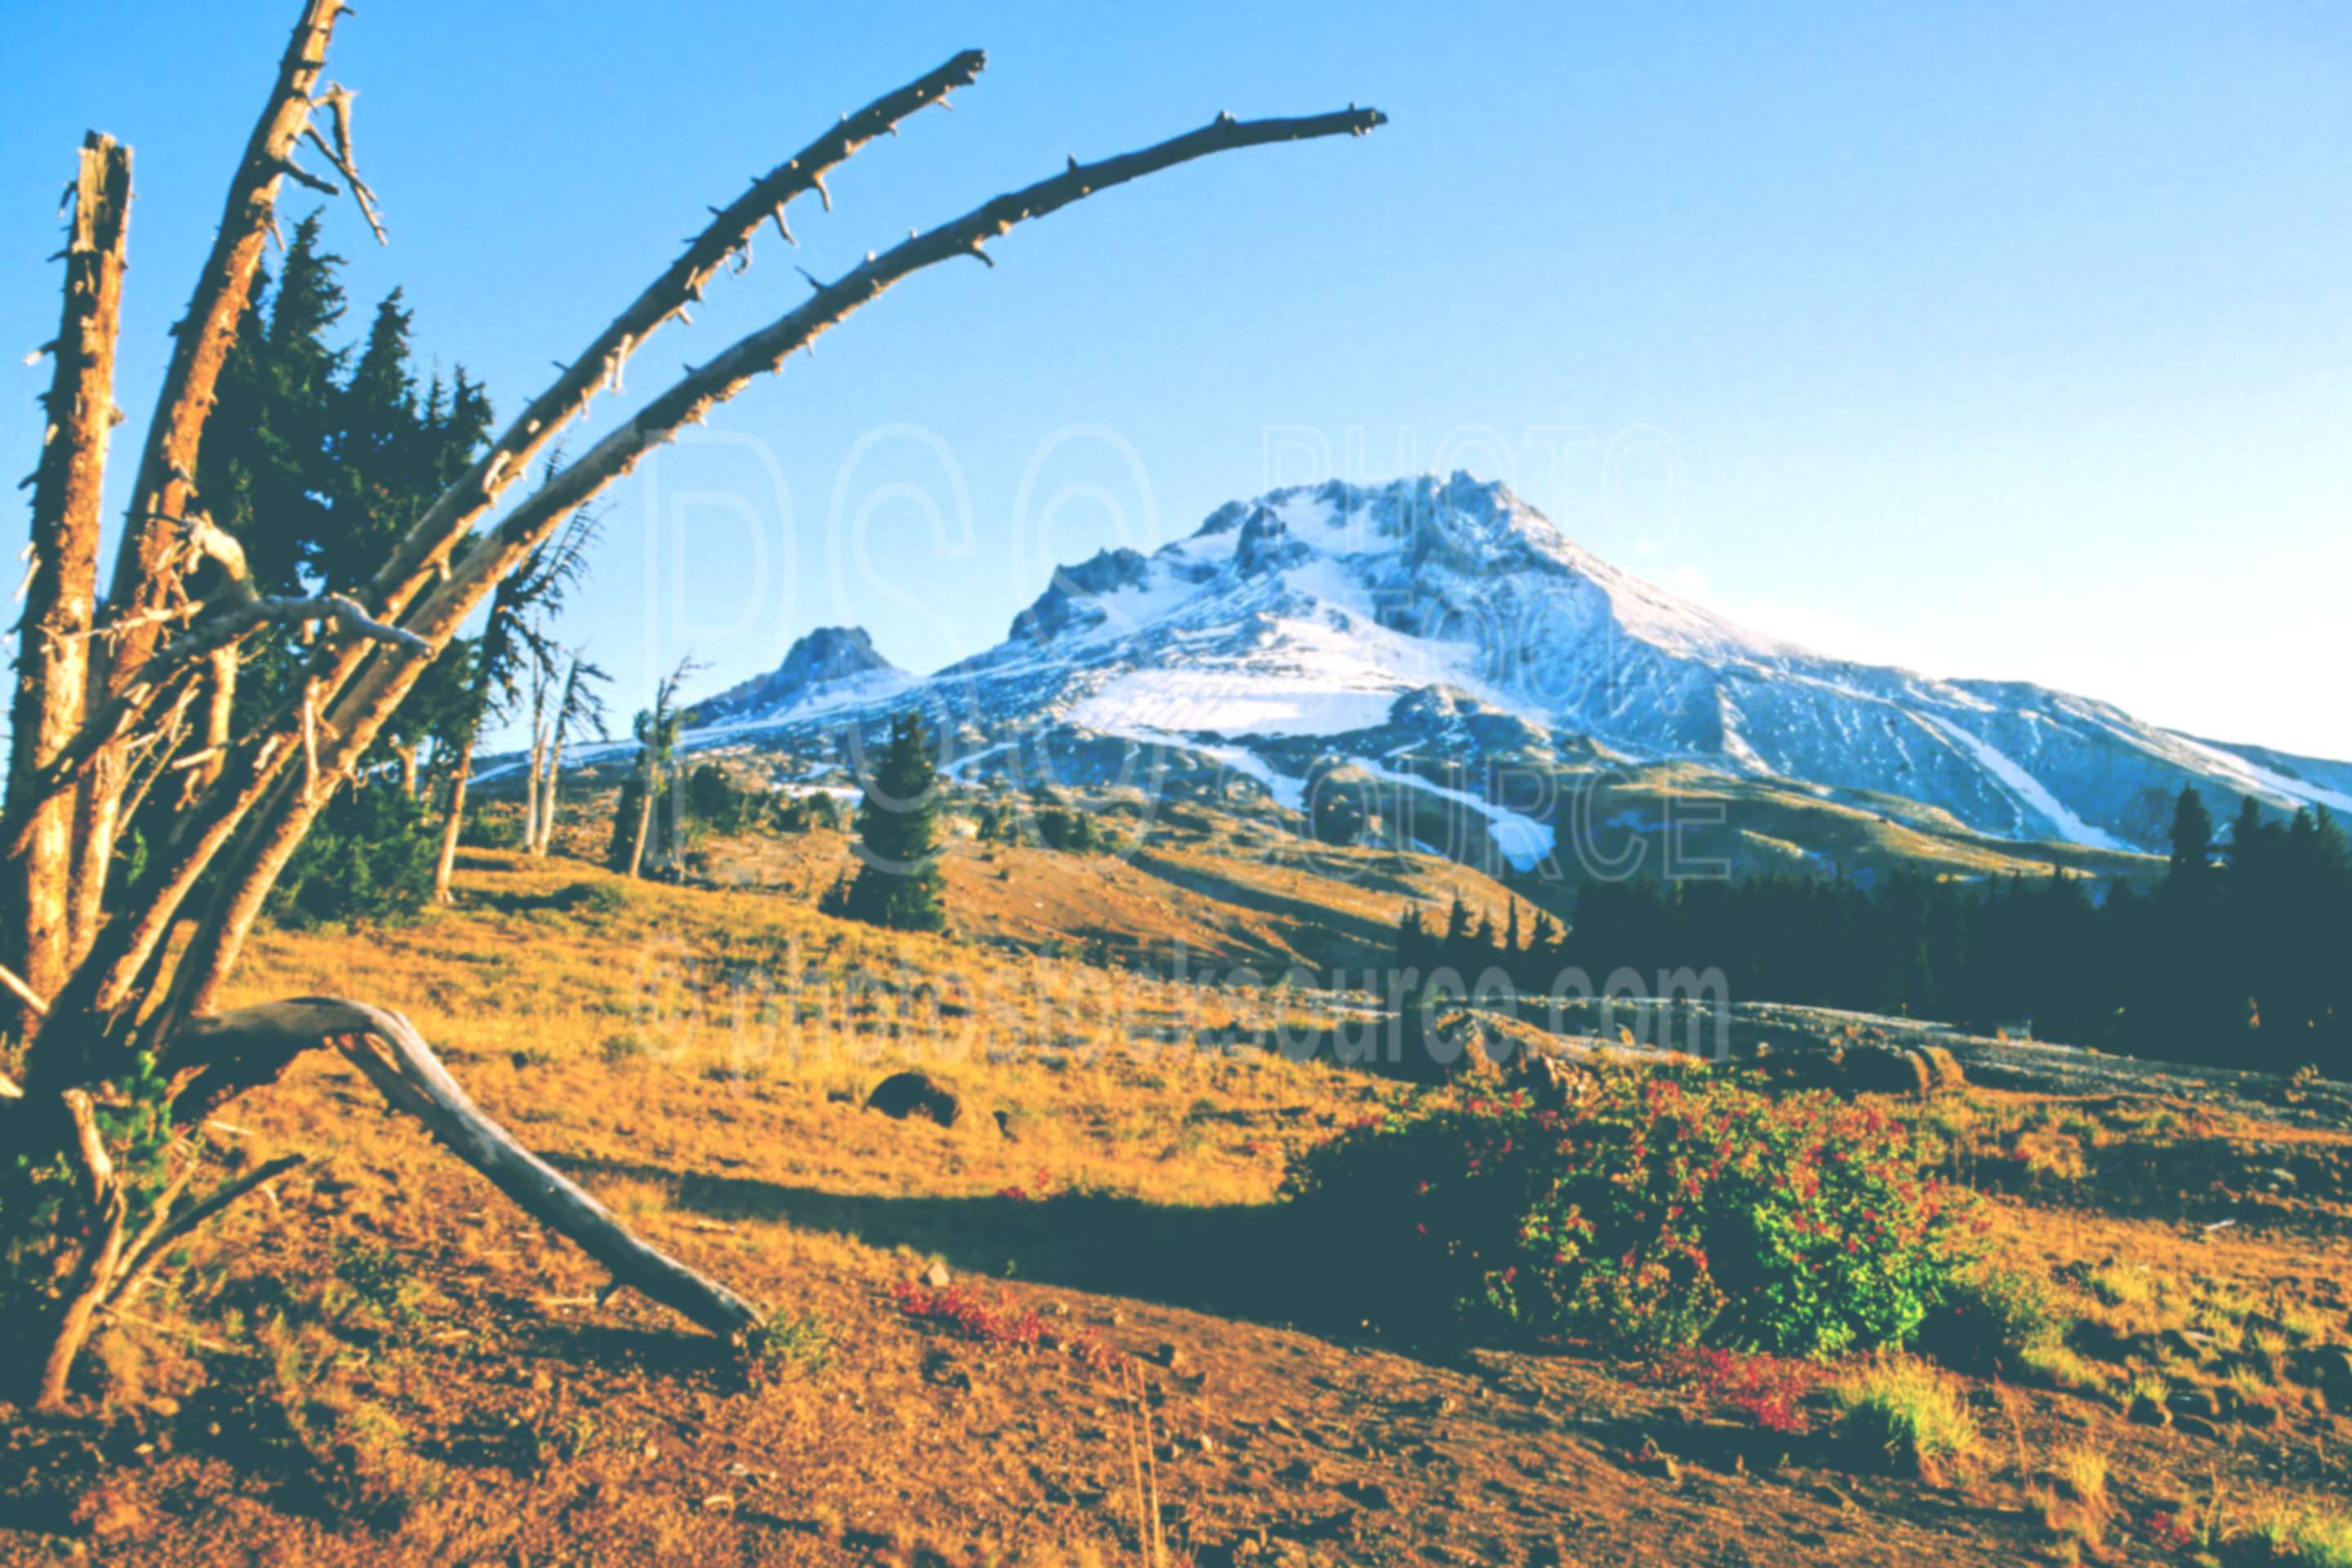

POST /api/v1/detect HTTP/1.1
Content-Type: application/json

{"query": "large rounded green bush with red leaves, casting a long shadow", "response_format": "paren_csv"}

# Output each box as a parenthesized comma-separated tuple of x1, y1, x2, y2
(1289, 1070, 1973, 1356)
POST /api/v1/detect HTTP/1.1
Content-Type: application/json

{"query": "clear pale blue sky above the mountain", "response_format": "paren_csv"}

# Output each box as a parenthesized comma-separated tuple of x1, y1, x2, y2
(0, 0, 2352, 757)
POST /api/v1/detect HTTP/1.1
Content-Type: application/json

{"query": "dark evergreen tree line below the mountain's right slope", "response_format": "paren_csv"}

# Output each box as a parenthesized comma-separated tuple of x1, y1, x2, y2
(1397, 787, 2352, 1076)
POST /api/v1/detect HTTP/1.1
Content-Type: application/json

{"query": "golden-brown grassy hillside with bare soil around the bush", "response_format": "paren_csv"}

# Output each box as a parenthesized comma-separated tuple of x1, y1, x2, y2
(0, 813, 2352, 1563)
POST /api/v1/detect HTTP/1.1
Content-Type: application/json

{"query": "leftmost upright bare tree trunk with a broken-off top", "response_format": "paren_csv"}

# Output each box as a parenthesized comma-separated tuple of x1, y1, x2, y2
(0, 131, 131, 1039)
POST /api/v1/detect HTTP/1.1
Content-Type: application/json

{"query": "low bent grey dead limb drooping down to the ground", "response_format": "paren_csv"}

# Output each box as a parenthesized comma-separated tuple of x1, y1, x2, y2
(174, 997, 760, 1338)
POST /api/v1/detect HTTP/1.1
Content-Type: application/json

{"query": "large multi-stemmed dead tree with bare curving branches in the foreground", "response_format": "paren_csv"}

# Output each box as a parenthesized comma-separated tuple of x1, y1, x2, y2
(0, 0, 1383, 1404)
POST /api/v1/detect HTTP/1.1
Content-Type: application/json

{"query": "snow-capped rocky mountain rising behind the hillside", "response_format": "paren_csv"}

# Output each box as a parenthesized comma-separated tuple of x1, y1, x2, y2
(663, 474, 2352, 858)
